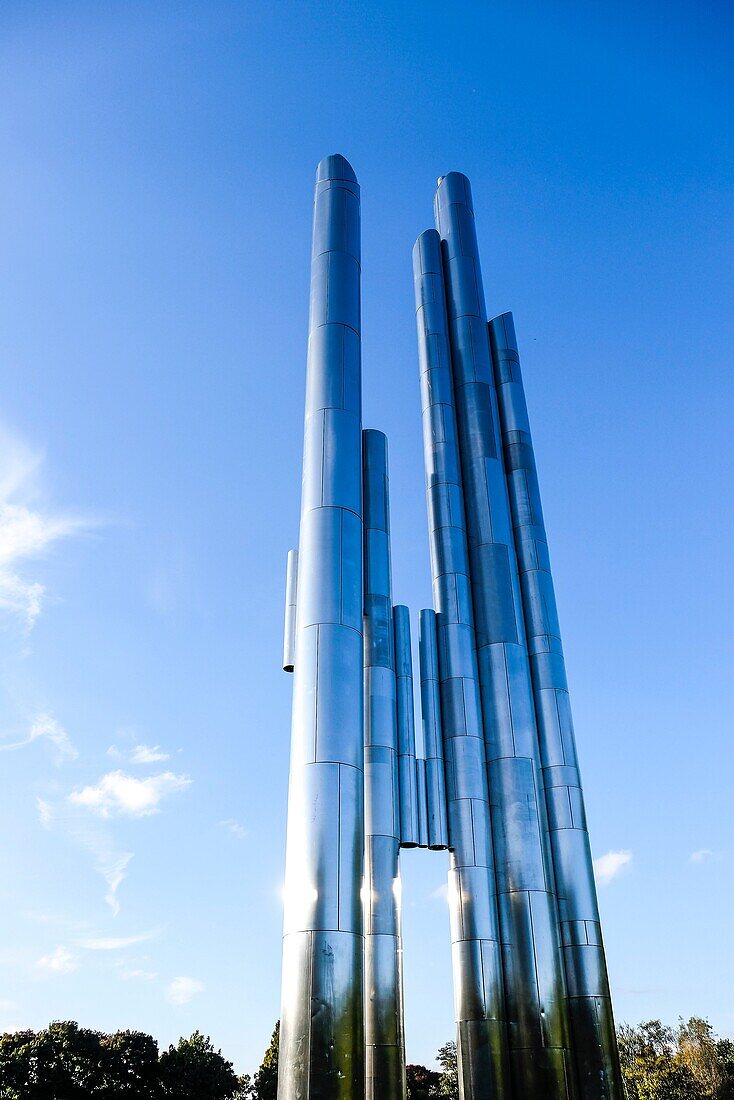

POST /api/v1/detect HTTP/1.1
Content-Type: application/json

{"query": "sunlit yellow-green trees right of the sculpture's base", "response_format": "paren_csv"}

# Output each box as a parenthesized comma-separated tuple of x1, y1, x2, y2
(617, 1016, 734, 1100)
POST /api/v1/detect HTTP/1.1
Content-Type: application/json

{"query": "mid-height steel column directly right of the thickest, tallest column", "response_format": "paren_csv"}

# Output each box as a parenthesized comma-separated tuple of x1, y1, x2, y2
(362, 430, 405, 1100)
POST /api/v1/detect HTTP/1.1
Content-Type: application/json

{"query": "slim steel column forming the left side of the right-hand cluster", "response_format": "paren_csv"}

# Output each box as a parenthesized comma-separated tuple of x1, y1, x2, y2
(413, 230, 510, 1100)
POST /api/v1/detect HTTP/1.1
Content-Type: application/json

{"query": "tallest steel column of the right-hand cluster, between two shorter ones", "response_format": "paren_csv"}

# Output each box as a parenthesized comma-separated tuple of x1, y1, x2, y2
(436, 172, 572, 1100)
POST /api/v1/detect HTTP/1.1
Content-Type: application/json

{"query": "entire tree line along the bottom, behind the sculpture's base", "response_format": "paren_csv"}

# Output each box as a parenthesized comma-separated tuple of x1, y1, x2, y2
(0, 1016, 734, 1100)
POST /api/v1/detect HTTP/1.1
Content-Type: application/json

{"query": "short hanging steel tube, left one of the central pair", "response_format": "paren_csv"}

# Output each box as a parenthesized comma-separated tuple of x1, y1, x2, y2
(393, 604, 418, 848)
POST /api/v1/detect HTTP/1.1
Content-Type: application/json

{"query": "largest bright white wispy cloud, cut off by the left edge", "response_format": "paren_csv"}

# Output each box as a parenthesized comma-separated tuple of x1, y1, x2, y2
(0, 429, 91, 631)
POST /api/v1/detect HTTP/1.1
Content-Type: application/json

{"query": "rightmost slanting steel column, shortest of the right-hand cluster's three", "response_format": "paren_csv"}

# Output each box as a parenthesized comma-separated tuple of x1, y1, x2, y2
(489, 314, 624, 1100)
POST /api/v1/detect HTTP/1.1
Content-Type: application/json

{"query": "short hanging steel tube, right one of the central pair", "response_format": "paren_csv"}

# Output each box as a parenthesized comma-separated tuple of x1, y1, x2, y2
(418, 607, 449, 850)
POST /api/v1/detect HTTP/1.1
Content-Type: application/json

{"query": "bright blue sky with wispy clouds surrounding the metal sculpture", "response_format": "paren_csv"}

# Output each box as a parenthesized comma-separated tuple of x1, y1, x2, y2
(0, 0, 734, 1070)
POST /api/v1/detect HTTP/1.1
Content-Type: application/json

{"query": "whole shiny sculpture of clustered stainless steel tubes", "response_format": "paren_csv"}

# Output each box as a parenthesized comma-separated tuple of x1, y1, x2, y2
(278, 155, 623, 1100)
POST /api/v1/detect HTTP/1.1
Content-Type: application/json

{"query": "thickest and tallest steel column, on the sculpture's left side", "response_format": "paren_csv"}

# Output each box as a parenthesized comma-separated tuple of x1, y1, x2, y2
(278, 155, 364, 1100)
